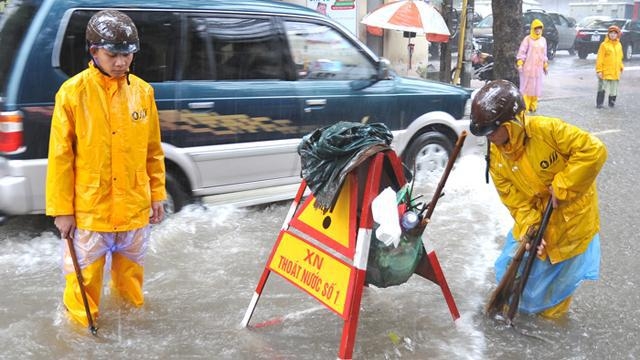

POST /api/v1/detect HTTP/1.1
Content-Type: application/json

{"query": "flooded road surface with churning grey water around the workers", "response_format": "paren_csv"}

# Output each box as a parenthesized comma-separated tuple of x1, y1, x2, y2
(0, 52, 640, 359)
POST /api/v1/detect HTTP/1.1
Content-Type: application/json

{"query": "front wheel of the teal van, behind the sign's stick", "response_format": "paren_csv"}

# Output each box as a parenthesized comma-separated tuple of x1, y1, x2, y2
(403, 131, 453, 183)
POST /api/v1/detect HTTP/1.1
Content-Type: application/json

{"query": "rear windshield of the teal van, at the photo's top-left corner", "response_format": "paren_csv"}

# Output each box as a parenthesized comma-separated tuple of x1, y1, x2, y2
(0, 0, 41, 97)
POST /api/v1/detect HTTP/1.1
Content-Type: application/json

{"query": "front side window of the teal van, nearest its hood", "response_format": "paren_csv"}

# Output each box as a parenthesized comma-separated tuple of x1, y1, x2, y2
(285, 21, 376, 80)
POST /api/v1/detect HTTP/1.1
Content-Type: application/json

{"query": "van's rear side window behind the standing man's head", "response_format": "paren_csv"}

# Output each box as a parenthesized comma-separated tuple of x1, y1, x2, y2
(60, 10, 179, 83)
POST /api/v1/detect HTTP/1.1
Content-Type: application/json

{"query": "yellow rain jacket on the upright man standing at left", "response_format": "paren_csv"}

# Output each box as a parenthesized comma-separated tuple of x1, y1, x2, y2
(46, 63, 166, 232)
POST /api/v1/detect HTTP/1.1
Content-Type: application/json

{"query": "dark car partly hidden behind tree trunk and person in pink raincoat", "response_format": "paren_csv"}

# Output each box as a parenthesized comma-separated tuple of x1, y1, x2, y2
(473, 10, 558, 60)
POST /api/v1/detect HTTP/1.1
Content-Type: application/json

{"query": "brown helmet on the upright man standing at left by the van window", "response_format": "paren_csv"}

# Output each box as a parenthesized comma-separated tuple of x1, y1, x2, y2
(85, 10, 140, 54)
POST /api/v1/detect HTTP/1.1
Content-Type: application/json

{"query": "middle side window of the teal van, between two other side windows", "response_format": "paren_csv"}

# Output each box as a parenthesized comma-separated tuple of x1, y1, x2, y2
(183, 15, 287, 80)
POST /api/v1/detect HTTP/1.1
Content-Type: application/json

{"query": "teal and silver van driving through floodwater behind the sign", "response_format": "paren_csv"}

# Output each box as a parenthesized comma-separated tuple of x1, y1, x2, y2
(0, 0, 471, 218)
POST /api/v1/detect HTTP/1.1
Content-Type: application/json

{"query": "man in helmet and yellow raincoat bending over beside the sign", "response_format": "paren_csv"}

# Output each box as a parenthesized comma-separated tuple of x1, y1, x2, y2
(470, 80, 607, 318)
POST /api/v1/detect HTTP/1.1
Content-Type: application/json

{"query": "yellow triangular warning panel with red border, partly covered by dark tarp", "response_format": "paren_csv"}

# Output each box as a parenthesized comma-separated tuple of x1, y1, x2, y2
(291, 174, 358, 257)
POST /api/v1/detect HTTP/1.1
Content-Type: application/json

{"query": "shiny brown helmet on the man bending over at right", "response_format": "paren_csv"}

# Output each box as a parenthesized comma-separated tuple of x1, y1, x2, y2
(469, 80, 525, 136)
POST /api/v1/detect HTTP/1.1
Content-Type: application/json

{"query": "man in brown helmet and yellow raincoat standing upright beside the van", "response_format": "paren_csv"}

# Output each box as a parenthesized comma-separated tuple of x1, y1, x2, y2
(46, 10, 166, 326)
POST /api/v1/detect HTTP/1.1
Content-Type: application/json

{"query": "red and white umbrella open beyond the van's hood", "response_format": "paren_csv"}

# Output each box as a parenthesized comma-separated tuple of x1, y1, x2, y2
(362, 0, 450, 42)
